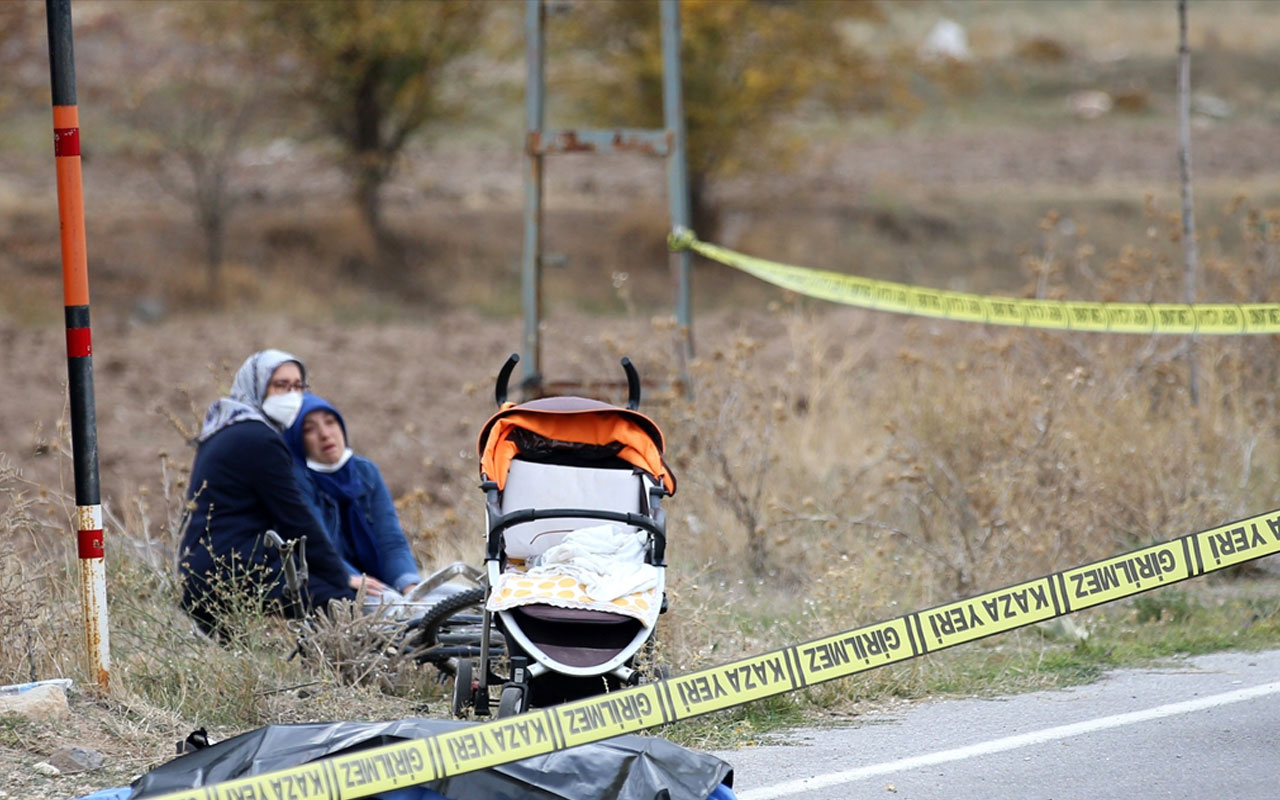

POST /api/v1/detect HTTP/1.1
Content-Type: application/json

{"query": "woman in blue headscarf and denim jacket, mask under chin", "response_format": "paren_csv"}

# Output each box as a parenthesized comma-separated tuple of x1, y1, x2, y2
(284, 393, 422, 602)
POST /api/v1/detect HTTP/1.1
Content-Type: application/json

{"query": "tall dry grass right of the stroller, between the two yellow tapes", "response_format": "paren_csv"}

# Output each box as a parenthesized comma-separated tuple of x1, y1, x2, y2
(671, 314, 1277, 622)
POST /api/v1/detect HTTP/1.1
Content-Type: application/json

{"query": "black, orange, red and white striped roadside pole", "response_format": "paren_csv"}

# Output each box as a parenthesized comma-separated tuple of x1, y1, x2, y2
(45, 0, 111, 691)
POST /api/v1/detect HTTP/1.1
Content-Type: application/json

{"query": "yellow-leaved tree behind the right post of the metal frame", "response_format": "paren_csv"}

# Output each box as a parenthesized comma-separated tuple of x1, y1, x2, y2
(548, 0, 910, 237)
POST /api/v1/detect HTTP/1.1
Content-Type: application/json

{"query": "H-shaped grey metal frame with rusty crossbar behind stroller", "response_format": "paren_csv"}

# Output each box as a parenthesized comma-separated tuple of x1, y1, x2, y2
(521, 0, 692, 396)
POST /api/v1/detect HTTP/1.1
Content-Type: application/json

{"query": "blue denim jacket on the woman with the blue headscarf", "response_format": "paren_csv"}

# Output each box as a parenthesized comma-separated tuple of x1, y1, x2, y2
(293, 456, 422, 591)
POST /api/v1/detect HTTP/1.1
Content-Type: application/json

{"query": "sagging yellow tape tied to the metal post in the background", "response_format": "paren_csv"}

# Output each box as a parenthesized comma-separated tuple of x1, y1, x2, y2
(667, 229, 1280, 334)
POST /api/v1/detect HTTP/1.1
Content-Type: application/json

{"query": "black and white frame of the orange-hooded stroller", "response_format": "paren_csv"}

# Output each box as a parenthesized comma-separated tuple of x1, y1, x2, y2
(463, 355, 671, 717)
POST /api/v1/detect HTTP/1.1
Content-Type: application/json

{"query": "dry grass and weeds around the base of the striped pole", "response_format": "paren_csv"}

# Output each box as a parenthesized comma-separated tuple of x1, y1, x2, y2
(0, 445, 440, 800)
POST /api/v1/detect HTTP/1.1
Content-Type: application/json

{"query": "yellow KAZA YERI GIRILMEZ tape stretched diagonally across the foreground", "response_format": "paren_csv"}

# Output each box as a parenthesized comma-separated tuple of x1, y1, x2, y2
(145, 509, 1280, 800)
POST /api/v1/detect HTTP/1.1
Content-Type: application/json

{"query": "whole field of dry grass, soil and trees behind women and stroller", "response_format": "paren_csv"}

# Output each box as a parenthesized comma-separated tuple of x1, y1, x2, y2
(0, 0, 1280, 797)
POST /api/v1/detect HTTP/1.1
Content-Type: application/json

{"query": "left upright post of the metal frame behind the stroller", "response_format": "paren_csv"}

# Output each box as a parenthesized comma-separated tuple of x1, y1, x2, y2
(520, 0, 547, 398)
